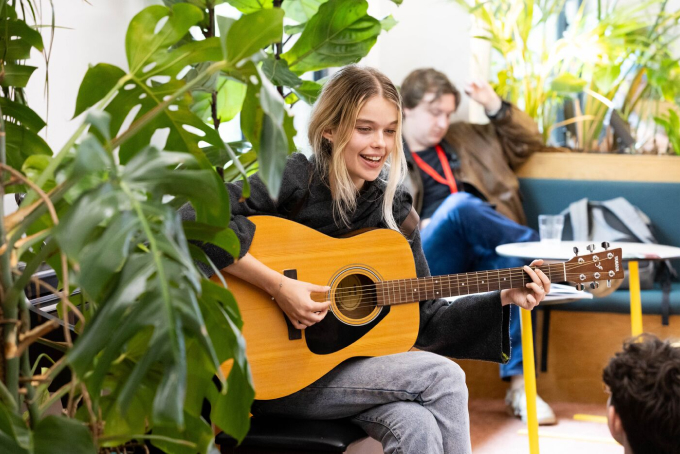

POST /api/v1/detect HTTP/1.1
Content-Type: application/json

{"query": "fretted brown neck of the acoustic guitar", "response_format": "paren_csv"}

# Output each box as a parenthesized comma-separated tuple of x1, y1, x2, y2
(376, 263, 567, 306)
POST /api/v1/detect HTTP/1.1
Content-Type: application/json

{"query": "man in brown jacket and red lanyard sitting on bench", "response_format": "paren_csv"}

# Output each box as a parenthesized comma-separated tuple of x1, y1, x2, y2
(401, 69, 557, 424)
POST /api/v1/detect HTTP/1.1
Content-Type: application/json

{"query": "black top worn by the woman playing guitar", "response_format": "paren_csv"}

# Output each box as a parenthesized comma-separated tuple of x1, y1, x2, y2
(180, 153, 510, 362)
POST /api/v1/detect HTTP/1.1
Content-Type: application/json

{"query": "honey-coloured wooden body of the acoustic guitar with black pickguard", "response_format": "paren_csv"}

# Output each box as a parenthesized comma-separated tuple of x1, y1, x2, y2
(213, 216, 419, 399)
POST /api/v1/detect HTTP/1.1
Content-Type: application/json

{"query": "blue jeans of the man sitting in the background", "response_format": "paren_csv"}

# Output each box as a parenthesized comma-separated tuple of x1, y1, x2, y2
(421, 192, 538, 378)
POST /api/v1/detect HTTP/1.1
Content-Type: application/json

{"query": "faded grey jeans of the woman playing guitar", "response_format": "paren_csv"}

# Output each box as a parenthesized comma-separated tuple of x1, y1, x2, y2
(252, 351, 471, 454)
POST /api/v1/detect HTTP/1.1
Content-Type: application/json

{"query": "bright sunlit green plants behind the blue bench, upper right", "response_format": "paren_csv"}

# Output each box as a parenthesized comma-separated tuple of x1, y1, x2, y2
(456, 0, 680, 153)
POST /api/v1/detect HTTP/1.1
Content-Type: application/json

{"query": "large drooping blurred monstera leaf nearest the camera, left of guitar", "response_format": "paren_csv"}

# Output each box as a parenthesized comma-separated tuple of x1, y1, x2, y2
(55, 143, 244, 428)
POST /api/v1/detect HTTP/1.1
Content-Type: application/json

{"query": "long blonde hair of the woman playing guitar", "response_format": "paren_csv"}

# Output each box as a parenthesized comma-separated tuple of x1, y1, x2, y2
(308, 65, 406, 231)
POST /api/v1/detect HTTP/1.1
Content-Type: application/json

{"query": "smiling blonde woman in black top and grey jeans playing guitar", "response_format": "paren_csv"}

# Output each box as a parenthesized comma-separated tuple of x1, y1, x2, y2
(183, 66, 550, 454)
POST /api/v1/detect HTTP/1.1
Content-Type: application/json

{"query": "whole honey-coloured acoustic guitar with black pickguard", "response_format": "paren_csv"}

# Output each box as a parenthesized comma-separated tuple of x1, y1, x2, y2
(212, 216, 623, 400)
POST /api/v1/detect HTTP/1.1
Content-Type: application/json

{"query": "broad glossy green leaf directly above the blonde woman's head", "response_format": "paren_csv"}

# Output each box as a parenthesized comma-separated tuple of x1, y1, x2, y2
(282, 0, 381, 74)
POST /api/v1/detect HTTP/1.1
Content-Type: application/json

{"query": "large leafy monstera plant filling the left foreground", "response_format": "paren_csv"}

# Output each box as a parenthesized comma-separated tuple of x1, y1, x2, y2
(0, 0, 396, 454)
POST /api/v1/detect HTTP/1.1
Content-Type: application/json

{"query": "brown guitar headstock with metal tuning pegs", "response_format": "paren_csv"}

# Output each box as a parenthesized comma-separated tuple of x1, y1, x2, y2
(564, 242, 623, 290)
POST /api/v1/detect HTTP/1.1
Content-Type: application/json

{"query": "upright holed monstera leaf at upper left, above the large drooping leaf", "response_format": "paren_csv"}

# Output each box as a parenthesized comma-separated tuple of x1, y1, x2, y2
(75, 3, 222, 167)
